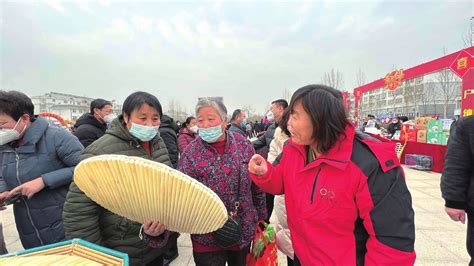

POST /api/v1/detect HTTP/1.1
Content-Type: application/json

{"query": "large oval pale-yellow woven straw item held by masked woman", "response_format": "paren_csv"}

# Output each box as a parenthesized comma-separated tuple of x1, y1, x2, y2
(74, 155, 227, 234)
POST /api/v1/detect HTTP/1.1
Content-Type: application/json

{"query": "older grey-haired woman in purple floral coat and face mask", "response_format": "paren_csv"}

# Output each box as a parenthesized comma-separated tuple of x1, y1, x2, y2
(178, 98, 266, 266)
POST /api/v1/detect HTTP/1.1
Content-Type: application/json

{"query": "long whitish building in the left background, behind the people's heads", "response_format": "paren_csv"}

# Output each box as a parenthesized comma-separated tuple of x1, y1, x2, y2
(31, 92, 122, 121)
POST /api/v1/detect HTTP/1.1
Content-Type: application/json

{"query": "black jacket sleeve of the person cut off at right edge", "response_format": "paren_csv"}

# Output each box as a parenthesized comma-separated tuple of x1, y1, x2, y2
(441, 118, 474, 210)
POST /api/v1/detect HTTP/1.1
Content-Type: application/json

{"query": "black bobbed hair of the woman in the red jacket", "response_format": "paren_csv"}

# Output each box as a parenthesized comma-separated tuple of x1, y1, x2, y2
(290, 85, 350, 154)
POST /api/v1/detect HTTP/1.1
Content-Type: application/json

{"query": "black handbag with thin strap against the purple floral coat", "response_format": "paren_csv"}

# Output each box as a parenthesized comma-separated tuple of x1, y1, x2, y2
(213, 157, 242, 248)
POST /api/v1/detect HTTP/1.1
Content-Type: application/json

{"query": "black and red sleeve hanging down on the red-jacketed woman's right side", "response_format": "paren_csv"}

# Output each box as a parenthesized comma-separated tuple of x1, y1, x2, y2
(351, 140, 416, 265)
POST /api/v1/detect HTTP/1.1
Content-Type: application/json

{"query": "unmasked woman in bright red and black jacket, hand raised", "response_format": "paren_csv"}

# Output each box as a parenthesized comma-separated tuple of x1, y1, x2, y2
(248, 85, 416, 265)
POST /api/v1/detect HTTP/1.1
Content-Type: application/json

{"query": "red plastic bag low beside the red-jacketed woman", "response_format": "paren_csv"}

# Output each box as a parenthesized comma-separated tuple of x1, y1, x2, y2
(247, 221, 278, 266)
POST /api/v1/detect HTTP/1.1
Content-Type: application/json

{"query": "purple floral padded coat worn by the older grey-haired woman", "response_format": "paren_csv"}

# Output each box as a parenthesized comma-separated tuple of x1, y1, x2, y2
(178, 131, 267, 248)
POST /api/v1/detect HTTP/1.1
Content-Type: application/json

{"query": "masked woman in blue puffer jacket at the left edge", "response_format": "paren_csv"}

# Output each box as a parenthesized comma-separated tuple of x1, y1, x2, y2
(0, 91, 84, 249)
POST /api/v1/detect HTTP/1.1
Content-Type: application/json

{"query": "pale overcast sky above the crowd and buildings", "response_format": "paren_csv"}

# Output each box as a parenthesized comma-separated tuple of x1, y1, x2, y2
(0, 0, 474, 112)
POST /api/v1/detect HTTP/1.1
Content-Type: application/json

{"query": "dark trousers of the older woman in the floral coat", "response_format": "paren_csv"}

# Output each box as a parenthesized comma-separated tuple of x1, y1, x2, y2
(193, 246, 250, 266)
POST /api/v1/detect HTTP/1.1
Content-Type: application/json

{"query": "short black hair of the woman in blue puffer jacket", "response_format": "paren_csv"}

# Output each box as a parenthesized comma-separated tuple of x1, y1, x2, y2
(0, 90, 35, 121)
